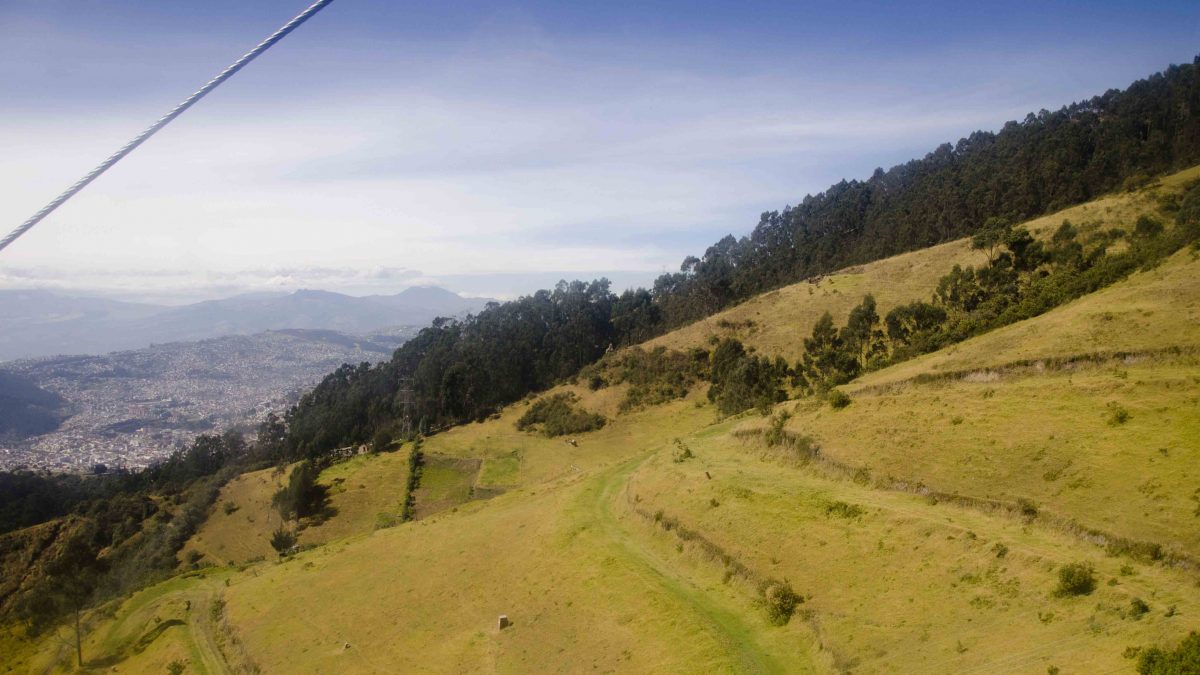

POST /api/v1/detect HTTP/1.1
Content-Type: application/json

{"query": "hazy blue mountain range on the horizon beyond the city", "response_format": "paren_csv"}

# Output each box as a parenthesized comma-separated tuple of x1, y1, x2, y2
(0, 287, 488, 362)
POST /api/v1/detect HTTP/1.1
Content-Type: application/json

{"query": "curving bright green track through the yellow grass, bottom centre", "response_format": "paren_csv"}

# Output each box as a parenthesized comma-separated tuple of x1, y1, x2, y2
(582, 456, 812, 673)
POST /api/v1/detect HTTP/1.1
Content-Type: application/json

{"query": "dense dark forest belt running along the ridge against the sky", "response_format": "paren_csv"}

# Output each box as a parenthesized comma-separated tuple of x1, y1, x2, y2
(278, 58, 1200, 455)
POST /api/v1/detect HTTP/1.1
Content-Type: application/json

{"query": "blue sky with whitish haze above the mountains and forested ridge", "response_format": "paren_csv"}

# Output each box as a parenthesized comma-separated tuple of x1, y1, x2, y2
(0, 0, 1200, 301)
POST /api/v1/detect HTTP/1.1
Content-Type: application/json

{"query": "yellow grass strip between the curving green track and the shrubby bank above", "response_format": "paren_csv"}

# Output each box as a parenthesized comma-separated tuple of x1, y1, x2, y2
(629, 422, 1200, 673)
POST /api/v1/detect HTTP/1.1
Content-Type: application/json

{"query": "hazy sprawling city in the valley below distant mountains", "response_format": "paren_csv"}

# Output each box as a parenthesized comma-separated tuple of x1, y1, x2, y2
(0, 329, 412, 472)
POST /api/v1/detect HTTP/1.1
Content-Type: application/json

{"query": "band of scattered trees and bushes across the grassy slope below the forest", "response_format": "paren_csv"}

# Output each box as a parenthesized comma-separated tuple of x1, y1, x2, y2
(708, 183, 1200, 414)
